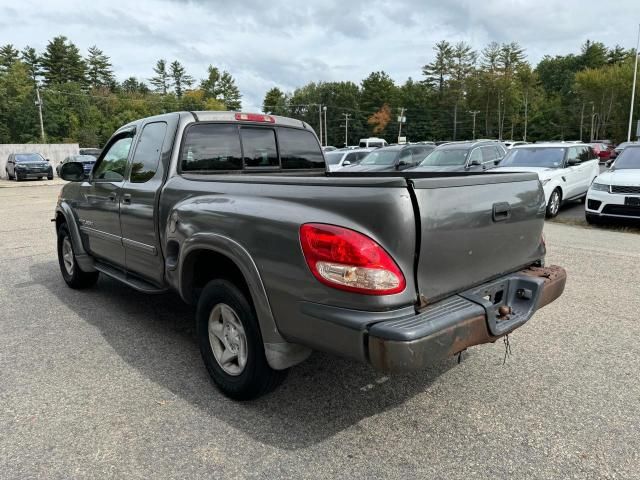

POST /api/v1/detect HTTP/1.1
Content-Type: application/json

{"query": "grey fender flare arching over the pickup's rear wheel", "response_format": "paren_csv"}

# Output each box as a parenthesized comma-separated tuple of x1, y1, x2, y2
(177, 233, 311, 370)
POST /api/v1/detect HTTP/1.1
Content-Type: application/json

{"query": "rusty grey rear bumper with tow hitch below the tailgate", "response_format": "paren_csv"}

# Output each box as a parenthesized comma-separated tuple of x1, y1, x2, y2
(367, 266, 567, 372)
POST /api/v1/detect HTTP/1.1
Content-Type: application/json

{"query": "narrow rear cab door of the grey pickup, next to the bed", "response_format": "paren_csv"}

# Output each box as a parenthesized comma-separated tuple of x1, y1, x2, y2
(120, 114, 179, 285)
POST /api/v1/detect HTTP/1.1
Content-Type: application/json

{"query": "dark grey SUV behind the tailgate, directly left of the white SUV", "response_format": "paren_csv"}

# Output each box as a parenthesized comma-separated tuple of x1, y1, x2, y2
(415, 140, 506, 172)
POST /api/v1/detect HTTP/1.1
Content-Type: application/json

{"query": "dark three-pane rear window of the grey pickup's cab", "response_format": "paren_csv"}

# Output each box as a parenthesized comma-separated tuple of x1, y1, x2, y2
(179, 122, 325, 173)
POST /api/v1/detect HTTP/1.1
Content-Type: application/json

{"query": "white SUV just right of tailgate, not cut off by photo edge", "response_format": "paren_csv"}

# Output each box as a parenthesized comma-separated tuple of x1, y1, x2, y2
(496, 143, 600, 218)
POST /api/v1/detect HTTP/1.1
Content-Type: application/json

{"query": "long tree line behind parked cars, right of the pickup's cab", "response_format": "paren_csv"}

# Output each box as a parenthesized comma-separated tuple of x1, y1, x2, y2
(263, 40, 639, 145)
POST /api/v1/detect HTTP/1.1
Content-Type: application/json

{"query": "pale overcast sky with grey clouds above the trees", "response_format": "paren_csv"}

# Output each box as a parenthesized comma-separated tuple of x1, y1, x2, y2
(0, 0, 640, 110)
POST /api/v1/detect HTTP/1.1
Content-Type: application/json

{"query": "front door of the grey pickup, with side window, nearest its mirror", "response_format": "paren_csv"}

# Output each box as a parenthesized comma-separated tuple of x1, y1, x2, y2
(77, 129, 135, 267)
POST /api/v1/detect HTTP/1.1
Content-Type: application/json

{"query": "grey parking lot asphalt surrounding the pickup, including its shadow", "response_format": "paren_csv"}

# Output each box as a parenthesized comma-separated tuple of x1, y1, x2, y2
(0, 185, 640, 479)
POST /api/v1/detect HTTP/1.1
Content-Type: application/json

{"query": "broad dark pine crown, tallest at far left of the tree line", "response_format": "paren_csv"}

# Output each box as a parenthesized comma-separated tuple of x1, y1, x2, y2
(41, 35, 87, 85)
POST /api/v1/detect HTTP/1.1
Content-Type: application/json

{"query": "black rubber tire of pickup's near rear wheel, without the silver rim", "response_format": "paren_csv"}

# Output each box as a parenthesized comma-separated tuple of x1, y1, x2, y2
(196, 280, 287, 400)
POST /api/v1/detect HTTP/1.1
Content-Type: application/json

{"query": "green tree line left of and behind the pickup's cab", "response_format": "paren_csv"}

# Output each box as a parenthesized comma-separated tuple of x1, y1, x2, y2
(0, 36, 242, 147)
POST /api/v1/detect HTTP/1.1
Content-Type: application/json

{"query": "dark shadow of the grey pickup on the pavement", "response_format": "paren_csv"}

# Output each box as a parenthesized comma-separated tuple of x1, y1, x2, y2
(32, 261, 455, 449)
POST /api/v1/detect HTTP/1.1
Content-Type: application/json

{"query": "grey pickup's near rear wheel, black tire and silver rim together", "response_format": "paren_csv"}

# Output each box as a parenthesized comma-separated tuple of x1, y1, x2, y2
(196, 280, 287, 400)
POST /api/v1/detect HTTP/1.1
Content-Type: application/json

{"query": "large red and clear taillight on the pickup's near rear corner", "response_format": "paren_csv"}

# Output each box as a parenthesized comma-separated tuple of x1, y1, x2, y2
(300, 223, 406, 295)
